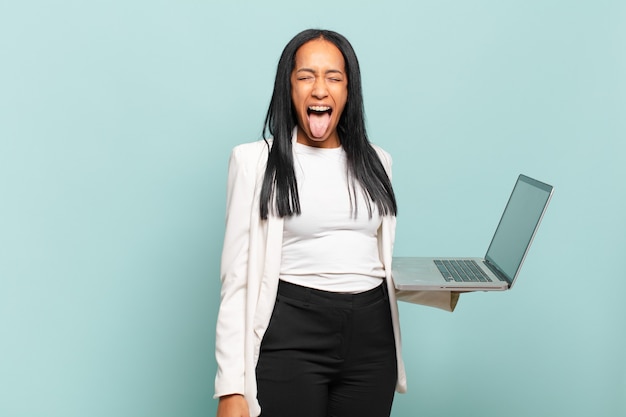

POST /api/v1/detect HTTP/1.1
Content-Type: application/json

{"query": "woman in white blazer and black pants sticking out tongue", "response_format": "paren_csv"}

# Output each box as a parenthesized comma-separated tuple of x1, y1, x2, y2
(215, 30, 458, 417)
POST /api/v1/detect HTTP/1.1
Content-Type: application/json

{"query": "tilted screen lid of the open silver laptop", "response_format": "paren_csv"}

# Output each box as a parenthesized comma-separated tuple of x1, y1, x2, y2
(485, 175, 552, 283)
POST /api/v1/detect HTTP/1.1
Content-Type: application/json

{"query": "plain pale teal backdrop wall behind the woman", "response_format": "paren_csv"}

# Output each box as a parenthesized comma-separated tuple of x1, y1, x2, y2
(0, 0, 626, 417)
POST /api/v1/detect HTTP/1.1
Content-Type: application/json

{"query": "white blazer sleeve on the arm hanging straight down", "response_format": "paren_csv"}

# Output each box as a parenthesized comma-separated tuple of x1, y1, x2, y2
(215, 147, 256, 398)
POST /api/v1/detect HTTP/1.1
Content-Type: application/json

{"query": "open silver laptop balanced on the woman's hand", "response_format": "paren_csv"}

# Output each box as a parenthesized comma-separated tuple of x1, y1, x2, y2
(392, 175, 553, 291)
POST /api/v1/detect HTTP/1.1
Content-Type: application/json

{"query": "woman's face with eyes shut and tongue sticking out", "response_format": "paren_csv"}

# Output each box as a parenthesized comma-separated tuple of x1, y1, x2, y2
(291, 39, 348, 148)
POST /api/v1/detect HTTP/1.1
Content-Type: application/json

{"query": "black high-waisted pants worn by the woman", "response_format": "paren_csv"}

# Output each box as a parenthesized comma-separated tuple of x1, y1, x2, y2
(256, 281, 397, 417)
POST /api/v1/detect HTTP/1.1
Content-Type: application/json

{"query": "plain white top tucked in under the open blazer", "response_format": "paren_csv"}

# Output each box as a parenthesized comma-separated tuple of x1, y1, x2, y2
(280, 142, 385, 293)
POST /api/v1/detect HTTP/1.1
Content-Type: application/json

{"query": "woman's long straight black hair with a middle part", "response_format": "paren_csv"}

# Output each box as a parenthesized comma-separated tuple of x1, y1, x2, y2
(260, 29, 398, 219)
